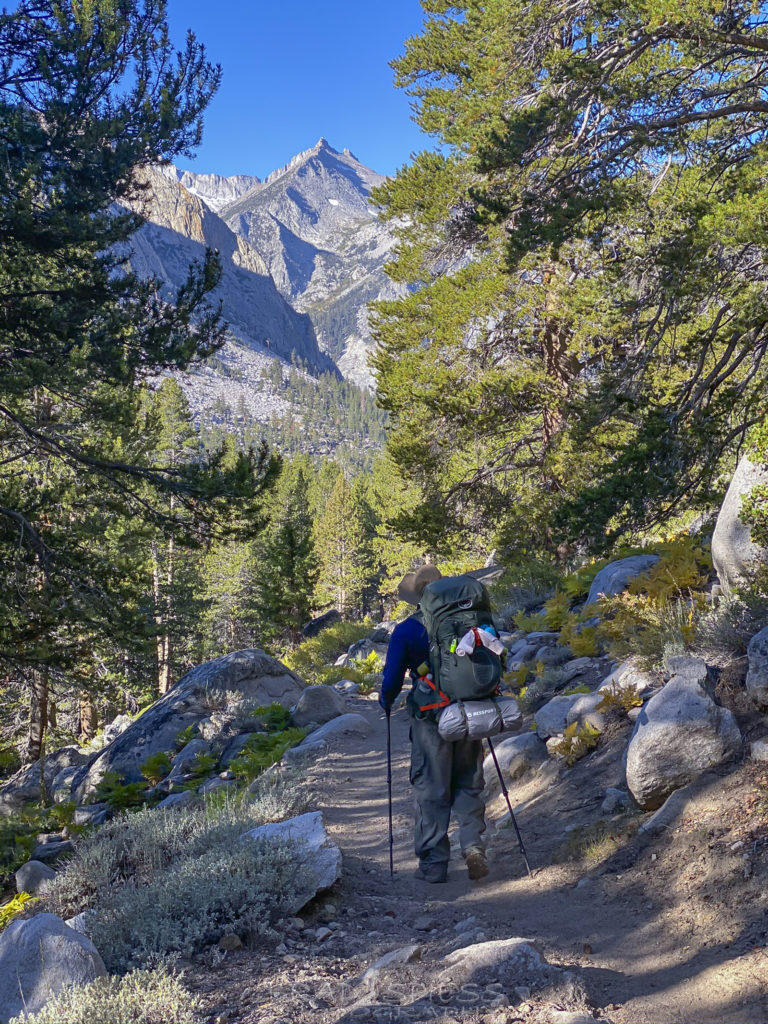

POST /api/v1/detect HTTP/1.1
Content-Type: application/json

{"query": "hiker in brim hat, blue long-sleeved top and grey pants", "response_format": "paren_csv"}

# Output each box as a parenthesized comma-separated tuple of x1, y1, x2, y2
(379, 565, 488, 884)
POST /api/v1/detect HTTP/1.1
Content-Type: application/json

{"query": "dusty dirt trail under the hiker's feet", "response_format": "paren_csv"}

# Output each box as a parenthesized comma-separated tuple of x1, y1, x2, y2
(186, 698, 768, 1024)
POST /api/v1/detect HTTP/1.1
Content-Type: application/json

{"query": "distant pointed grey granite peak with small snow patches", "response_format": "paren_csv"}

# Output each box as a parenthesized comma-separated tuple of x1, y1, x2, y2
(220, 138, 401, 385)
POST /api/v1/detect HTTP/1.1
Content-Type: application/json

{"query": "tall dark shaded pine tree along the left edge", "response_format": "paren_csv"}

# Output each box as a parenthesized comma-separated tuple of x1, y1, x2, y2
(0, 0, 275, 754)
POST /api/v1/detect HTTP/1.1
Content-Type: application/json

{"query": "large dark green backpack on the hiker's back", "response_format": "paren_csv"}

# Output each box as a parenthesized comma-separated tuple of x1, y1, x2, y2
(420, 575, 502, 700)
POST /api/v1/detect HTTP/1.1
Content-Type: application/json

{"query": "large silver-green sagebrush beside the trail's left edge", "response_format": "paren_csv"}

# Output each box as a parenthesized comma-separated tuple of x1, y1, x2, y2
(41, 782, 313, 973)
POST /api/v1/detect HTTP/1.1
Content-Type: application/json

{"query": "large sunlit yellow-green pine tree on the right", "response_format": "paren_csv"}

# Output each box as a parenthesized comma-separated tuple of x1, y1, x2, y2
(376, 0, 768, 557)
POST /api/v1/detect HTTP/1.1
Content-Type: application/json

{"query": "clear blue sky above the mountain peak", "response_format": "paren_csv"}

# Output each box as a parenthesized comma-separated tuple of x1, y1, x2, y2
(168, 0, 430, 177)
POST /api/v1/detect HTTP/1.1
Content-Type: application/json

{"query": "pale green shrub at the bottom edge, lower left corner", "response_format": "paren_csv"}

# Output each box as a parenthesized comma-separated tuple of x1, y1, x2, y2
(12, 968, 204, 1024)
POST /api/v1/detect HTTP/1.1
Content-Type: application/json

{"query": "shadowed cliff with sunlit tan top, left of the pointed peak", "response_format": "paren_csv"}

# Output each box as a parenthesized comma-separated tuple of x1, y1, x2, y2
(130, 167, 336, 373)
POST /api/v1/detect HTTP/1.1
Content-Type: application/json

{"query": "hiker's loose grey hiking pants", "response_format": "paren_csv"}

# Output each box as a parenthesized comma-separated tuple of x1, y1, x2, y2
(411, 716, 485, 865)
